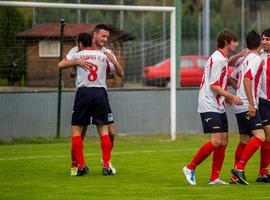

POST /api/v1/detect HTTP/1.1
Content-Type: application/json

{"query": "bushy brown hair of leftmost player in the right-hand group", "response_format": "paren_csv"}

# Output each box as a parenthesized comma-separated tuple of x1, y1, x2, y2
(217, 28, 239, 49)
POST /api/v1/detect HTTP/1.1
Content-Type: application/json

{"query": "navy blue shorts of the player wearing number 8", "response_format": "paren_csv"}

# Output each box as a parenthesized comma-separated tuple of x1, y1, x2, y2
(71, 87, 113, 126)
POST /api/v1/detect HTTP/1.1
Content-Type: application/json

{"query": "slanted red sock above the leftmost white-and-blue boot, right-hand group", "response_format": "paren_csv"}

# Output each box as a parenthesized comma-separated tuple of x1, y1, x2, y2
(187, 141, 215, 170)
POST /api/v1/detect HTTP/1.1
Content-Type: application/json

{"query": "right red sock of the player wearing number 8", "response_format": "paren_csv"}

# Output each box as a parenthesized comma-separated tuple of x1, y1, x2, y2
(100, 135, 112, 168)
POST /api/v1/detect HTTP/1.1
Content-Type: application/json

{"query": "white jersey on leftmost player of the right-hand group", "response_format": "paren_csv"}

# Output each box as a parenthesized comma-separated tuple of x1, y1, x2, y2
(198, 50, 228, 113)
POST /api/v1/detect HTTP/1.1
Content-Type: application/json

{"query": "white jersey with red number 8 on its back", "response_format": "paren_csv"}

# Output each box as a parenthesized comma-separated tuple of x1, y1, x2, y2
(66, 48, 114, 88)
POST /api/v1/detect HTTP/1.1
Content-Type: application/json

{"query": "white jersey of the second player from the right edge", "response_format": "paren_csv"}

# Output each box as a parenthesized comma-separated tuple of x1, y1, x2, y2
(232, 52, 262, 113)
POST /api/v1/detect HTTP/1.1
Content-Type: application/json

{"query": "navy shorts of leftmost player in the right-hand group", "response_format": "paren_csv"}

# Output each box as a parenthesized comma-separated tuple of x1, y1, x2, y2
(200, 112, 228, 133)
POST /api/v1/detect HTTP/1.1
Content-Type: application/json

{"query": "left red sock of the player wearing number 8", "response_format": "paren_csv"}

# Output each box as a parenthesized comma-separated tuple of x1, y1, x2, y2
(72, 135, 85, 169)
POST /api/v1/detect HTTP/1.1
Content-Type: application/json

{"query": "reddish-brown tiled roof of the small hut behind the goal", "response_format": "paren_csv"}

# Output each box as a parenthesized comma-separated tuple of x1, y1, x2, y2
(17, 23, 95, 38)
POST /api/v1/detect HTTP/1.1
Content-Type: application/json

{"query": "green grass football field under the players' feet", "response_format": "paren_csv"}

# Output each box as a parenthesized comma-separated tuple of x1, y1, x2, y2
(0, 134, 270, 200)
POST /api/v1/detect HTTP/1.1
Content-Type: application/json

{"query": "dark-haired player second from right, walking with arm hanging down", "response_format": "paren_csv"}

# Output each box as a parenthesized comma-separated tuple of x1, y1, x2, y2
(231, 31, 265, 185)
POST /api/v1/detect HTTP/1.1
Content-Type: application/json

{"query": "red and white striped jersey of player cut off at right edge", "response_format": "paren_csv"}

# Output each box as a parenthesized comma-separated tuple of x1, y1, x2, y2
(260, 51, 270, 101)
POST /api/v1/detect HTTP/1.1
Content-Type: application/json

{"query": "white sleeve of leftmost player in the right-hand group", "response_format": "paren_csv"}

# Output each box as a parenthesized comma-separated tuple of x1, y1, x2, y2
(209, 59, 224, 85)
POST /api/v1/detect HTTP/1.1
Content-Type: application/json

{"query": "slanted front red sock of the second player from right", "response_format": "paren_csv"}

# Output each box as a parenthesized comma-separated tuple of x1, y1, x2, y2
(236, 137, 263, 170)
